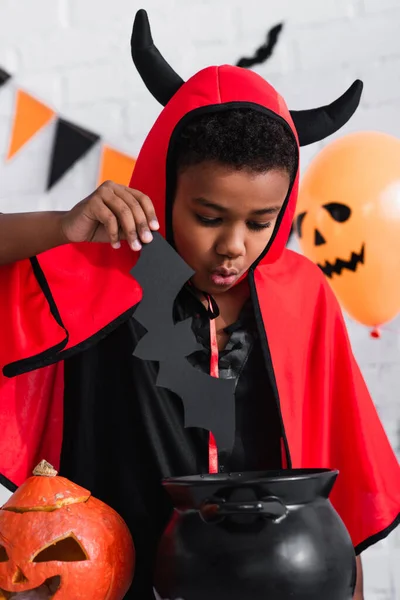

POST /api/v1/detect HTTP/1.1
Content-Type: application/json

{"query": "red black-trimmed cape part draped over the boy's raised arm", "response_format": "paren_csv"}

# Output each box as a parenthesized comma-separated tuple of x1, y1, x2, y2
(0, 243, 141, 377)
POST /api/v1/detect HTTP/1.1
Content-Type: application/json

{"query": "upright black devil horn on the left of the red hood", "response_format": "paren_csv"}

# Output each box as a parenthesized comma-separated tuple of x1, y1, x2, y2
(131, 9, 184, 106)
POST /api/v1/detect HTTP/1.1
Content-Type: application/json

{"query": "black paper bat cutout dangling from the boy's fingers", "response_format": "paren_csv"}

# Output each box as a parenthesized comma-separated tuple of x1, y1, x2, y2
(131, 233, 236, 456)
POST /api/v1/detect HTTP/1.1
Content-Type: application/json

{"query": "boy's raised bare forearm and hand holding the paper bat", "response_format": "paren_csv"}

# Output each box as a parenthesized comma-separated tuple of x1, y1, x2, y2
(0, 181, 159, 265)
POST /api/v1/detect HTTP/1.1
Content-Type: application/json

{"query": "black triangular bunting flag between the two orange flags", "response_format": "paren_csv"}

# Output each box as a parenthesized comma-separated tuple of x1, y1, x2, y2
(47, 119, 100, 190)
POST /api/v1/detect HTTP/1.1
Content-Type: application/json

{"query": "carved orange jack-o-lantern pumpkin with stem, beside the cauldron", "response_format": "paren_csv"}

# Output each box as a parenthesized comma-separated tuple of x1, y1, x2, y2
(0, 461, 135, 600)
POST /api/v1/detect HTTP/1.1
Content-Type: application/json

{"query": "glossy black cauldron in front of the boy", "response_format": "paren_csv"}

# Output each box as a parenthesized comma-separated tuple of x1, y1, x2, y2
(154, 469, 356, 600)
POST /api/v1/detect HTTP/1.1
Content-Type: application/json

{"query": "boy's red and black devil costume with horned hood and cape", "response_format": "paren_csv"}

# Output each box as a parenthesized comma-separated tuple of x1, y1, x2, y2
(0, 11, 400, 600)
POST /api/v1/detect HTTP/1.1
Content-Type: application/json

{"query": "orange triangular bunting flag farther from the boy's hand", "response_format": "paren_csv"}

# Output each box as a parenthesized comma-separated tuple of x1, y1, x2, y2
(7, 90, 54, 160)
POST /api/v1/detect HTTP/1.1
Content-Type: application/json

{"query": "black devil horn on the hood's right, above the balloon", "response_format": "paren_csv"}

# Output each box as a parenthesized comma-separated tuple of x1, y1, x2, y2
(290, 79, 363, 146)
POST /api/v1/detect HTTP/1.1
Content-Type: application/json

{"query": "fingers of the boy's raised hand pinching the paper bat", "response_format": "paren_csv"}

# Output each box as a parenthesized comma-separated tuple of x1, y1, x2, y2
(98, 182, 159, 251)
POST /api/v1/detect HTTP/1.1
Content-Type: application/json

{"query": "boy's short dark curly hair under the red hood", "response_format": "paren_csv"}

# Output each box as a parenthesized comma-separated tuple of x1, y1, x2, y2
(174, 108, 297, 179)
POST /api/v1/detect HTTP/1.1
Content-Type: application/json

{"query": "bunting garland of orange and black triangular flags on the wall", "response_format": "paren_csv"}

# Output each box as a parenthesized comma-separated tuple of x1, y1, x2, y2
(0, 68, 136, 191)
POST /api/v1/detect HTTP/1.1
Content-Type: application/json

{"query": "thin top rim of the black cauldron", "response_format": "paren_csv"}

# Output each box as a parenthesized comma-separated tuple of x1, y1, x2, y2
(162, 468, 339, 487)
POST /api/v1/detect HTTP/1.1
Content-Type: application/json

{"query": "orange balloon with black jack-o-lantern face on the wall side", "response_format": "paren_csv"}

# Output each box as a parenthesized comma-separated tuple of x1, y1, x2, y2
(295, 132, 400, 327)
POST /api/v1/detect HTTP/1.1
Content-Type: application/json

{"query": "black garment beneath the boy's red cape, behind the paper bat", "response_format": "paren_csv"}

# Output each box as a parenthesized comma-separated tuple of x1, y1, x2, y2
(60, 290, 281, 600)
